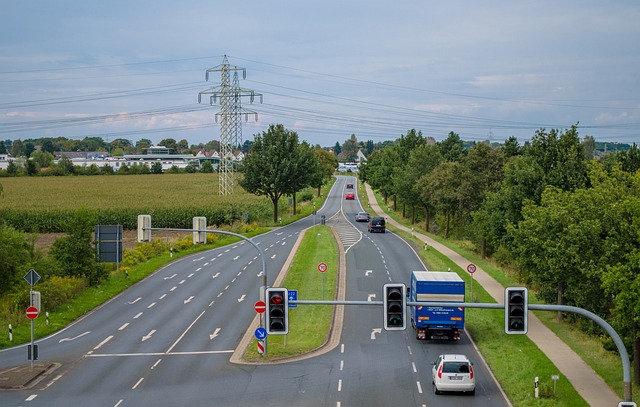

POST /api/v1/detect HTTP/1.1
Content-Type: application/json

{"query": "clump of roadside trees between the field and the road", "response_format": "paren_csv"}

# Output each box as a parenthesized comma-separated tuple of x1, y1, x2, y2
(240, 124, 338, 222)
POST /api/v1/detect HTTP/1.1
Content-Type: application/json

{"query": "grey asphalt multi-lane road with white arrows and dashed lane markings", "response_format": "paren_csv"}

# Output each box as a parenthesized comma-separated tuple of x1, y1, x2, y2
(0, 177, 508, 407)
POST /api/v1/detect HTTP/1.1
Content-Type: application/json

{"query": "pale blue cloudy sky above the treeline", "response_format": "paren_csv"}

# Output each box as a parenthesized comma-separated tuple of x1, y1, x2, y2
(0, 0, 640, 147)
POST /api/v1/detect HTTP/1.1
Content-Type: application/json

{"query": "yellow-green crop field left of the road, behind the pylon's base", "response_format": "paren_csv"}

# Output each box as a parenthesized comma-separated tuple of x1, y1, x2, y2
(0, 173, 278, 233)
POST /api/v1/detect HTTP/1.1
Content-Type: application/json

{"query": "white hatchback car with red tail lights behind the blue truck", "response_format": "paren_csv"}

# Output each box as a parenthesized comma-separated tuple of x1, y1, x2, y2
(431, 354, 476, 395)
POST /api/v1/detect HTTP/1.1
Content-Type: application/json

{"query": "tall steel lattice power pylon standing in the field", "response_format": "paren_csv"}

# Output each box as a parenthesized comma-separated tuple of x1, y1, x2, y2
(198, 55, 262, 195)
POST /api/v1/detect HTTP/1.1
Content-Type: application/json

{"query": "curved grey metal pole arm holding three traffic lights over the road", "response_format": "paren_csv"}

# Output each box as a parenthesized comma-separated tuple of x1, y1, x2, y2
(289, 300, 632, 401)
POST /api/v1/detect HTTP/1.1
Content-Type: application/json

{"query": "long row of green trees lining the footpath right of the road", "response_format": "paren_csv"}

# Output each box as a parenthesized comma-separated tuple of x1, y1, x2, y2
(360, 126, 640, 384)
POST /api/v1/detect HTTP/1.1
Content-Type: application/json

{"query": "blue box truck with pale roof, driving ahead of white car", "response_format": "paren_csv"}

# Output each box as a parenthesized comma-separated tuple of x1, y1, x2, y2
(409, 271, 465, 341)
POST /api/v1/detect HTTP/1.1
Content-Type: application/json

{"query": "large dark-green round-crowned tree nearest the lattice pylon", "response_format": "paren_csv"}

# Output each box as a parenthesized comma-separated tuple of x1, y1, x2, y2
(240, 124, 305, 222)
